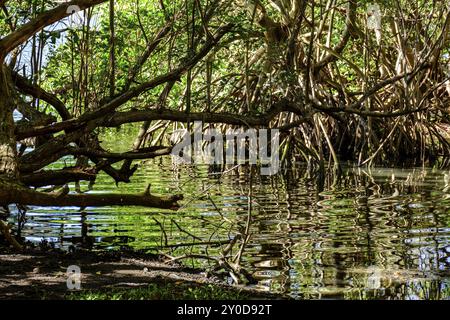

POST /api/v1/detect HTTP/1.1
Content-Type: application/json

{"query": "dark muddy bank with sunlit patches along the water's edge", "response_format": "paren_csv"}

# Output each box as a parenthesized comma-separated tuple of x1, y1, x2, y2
(0, 249, 280, 300)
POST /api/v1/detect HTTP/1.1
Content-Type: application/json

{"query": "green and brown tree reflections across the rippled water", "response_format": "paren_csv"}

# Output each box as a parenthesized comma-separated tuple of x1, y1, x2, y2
(24, 161, 449, 299)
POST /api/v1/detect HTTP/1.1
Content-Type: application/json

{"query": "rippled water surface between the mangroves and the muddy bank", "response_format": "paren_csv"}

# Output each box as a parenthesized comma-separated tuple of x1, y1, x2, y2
(8, 159, 450, 299)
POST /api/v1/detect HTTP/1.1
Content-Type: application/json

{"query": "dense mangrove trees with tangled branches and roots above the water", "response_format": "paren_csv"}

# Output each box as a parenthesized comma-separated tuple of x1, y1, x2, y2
(0, 0, 450, 248)
